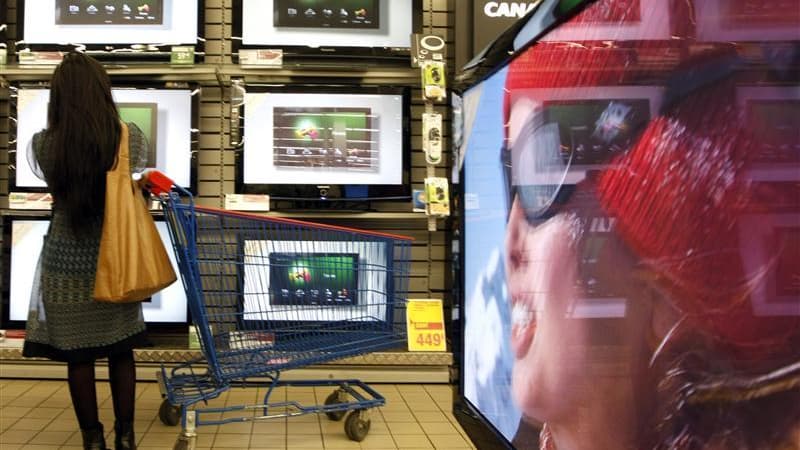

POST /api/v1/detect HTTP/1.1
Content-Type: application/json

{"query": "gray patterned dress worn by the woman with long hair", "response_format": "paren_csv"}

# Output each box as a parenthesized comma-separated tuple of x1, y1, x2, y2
(22, 124, 148, 362)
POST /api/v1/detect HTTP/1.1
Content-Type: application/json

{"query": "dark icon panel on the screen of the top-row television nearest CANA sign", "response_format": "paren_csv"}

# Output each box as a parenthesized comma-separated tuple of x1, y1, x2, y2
(273, 0, 380, 29)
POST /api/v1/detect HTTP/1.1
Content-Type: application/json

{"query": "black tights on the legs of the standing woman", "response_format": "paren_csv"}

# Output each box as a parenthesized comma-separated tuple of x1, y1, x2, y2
(67, 350, 136, 430)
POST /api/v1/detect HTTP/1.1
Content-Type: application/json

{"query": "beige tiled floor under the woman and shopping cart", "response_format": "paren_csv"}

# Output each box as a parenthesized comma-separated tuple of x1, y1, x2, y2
(0, 380, 475, 450)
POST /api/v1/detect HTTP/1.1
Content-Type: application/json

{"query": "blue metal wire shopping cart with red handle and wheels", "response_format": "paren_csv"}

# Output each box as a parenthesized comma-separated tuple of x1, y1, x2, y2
(149, 173, 411, 449)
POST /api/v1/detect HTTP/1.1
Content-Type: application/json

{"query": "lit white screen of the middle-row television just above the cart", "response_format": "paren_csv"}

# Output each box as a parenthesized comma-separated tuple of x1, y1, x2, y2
(242, 92, 403, 185)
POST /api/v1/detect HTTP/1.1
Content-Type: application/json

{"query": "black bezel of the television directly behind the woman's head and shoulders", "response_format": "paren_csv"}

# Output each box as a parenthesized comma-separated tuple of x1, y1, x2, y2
(8, 78, 201, 195)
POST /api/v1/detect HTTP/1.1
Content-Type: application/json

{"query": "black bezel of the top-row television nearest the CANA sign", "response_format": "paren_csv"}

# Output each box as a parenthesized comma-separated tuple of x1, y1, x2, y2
(231, 0, 422, 66)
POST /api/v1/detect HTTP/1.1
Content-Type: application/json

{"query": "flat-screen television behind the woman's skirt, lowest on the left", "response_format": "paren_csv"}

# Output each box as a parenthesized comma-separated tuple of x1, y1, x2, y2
(0, 215, 189, 332)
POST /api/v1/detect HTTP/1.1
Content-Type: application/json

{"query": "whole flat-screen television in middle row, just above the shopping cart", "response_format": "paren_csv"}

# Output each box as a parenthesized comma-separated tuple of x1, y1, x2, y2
(236, 86, 410, 201)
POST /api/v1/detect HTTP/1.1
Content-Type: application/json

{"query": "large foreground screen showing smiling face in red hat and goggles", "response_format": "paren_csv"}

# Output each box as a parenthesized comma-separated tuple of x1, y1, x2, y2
(454, 0, 800, 450)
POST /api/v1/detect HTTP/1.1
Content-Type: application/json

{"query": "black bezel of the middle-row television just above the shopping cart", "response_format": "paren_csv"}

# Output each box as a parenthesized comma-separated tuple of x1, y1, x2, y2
(235, 84, 411, 203)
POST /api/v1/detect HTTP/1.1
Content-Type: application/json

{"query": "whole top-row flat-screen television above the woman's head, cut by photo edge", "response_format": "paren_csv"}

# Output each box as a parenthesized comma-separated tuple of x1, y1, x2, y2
(17, 0, 205, 61)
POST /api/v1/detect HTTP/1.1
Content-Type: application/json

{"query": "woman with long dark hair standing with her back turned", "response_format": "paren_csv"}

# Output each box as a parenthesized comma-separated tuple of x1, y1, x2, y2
(23, 53, 148, 449)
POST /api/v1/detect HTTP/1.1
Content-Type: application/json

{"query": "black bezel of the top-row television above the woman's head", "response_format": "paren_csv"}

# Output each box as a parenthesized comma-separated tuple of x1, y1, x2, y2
(16, 0, 205, 63)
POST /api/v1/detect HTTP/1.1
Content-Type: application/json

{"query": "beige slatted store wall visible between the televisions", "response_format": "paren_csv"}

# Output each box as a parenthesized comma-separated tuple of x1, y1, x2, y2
(0, 0, 460, 334)
